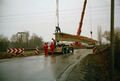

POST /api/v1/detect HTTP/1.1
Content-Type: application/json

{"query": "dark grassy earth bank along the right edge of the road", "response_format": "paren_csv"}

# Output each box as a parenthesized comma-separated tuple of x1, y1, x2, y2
(66, 48, 120, 81)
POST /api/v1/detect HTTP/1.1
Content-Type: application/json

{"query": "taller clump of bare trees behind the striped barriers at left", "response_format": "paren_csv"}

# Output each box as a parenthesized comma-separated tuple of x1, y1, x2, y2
(11, 32, 43, 49)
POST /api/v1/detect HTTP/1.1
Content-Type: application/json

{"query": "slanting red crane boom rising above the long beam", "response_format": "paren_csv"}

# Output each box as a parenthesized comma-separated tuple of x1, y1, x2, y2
(77, 0, 87, 35)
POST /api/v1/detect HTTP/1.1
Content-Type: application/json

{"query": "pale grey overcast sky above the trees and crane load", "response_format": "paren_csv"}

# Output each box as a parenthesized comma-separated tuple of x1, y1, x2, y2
(0, 0, 120, 41)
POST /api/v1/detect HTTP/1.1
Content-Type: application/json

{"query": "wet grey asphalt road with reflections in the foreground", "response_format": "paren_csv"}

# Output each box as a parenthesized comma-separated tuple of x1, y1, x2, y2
(0, 49, 92, 81)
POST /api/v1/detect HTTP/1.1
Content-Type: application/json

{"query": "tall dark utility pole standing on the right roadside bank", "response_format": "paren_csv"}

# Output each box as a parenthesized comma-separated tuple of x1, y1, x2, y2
(110, 0, 115, 81)
